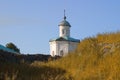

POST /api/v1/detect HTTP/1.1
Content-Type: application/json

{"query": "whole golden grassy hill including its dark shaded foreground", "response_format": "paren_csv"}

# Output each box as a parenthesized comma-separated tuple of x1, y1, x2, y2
(0, 32, 120, 80)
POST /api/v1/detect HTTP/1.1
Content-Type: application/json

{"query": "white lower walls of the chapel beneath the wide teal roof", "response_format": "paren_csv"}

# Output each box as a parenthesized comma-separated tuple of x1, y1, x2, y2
(50, 41, 78, 56)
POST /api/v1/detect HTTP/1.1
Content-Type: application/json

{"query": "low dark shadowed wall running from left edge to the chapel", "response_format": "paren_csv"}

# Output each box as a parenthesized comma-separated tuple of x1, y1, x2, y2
(0, 50, 51, 63)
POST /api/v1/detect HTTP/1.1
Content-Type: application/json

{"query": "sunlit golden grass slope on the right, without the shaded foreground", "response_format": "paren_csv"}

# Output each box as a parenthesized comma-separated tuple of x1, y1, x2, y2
(32, 32, 120, 80)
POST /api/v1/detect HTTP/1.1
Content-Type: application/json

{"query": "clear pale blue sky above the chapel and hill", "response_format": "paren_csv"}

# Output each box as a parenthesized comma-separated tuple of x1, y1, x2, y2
(0, 0, 120, 54)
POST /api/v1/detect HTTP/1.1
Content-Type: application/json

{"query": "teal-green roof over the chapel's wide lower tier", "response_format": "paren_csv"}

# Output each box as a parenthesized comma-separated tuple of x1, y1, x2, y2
(50, 37, 80, 43)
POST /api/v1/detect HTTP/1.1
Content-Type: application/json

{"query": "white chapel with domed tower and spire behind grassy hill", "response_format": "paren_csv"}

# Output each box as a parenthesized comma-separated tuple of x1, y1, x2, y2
(49, 11, 80, 56)
